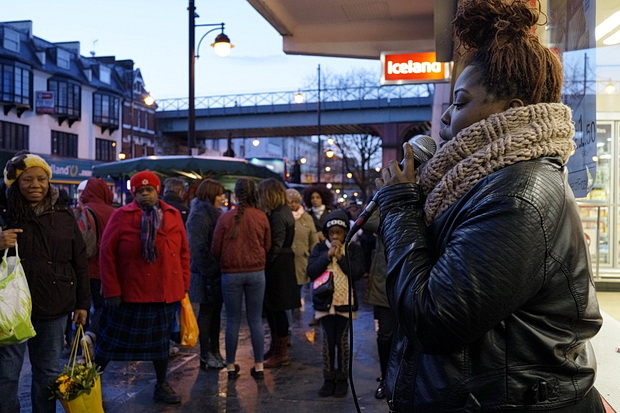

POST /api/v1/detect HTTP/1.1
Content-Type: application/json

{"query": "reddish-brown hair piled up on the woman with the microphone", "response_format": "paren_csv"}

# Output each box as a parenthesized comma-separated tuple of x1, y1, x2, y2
(452, 0, 563, 105)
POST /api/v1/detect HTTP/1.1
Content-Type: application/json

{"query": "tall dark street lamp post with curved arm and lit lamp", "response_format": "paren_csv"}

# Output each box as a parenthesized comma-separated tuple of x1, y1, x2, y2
(187, 0, 233, 155)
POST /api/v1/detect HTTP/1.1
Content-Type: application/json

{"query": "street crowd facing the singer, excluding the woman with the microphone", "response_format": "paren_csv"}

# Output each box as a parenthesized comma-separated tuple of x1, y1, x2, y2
(0, 157, 382, 413)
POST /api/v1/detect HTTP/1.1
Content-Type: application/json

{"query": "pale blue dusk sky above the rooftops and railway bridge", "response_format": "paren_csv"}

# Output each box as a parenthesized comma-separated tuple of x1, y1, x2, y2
(0, 0, 380, 99)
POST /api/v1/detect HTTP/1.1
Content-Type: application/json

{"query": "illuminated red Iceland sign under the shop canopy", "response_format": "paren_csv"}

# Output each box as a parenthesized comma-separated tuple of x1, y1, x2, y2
(381, 52, 450, 85)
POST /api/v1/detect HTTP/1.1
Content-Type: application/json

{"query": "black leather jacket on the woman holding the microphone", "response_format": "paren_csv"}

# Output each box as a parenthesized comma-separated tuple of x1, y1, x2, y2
(378, 158, 602, 413)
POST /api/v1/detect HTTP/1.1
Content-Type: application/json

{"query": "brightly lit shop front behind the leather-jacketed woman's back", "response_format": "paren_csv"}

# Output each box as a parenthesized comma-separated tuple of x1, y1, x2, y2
(538, 0, 620, 281)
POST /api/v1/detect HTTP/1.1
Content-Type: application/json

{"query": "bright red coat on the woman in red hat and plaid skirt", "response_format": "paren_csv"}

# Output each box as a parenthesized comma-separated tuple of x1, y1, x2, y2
(99, 201, 189, 303)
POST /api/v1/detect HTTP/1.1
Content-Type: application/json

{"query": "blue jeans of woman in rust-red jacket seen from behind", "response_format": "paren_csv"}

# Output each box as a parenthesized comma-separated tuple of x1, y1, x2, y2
(222, 271, 265, 364)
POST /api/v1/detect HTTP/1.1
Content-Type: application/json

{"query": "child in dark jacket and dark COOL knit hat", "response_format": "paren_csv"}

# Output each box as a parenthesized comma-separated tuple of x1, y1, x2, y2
(307, 210, 364, 397)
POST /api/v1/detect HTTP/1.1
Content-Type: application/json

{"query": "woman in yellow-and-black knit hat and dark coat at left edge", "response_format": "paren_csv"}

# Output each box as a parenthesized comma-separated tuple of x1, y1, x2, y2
(0, 151, 90, 413)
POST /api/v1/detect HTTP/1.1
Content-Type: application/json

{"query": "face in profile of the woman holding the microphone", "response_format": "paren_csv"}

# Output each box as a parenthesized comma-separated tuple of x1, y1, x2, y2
(439, 65, 523, 145)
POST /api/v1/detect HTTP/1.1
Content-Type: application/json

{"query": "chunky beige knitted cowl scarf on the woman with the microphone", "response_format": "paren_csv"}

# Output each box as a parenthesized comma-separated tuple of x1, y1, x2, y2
(419, 103, 575, 225)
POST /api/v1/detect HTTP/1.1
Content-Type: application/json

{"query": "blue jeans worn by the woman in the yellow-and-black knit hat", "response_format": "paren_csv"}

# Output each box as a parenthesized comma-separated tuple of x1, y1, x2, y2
(0, 316, 67, 413)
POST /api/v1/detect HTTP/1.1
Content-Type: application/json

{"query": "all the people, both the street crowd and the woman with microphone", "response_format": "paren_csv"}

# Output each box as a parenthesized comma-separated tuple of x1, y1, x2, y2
(0, 0, 604, 413)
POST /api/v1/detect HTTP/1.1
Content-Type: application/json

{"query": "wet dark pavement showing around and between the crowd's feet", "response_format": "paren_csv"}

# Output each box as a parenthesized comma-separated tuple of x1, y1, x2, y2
(20, 281, 388, 413)
